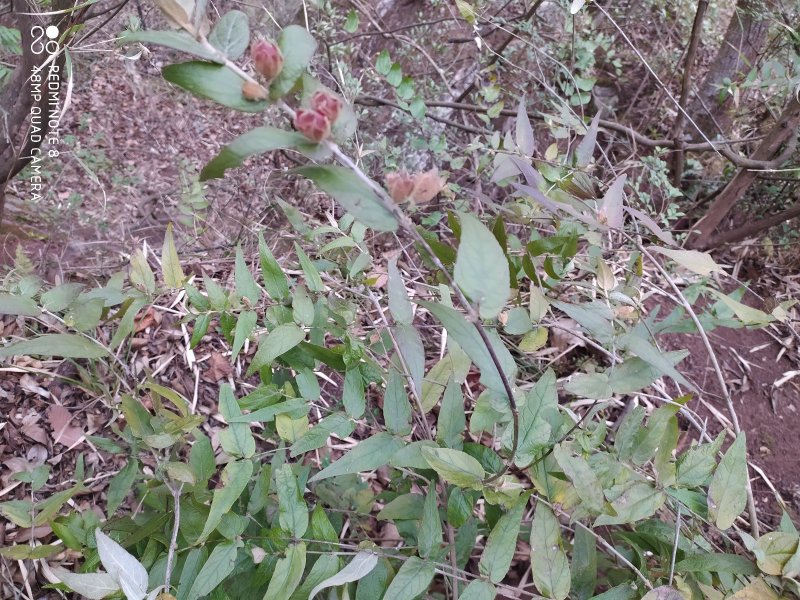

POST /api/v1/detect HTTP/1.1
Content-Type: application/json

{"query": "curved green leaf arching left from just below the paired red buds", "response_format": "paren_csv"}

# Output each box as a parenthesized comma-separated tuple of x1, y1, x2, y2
(200, 125, 316, 180)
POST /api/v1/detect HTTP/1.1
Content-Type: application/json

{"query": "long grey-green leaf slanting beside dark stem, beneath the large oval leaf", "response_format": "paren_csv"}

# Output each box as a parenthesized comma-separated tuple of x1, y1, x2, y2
(419, 300, 517, 394)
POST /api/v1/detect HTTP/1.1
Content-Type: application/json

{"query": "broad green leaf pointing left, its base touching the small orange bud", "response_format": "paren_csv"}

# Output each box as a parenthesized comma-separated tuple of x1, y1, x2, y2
(161, 60, 268, 112)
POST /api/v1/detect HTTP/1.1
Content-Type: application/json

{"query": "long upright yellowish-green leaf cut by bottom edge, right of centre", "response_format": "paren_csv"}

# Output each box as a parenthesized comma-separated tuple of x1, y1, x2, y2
(530, 502, 570, 600)
